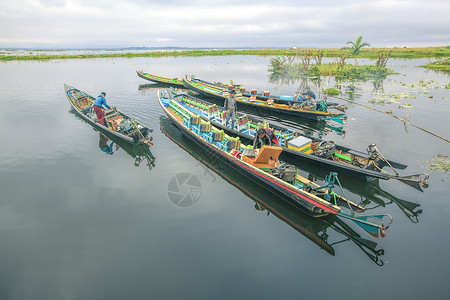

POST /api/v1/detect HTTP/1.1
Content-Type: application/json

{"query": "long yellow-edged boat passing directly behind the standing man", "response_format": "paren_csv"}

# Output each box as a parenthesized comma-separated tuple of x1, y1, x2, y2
(183, 77, 347, 123)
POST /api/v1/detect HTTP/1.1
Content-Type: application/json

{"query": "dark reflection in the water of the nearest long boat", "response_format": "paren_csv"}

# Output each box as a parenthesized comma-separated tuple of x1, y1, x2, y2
(160, 117, 384, 265)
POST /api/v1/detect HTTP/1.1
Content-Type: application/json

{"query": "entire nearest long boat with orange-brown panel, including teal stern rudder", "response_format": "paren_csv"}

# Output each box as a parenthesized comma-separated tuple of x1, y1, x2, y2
(158, 90, 392, 236)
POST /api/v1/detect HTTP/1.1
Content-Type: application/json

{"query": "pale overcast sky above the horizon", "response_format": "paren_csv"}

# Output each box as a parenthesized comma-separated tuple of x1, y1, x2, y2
(0, 0, 450, 48)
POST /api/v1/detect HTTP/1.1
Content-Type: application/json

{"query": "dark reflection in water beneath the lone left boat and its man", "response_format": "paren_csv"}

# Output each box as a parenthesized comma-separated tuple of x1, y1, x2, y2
(72, 112, 155, 170)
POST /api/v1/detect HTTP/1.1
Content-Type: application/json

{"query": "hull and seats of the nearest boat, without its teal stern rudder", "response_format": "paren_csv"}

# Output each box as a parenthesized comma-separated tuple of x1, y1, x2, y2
(158, 90, 370, 217)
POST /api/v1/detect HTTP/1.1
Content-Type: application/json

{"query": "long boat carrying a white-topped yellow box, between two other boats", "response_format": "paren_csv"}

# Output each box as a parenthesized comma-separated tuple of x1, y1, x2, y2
(170, 93, 430, 188)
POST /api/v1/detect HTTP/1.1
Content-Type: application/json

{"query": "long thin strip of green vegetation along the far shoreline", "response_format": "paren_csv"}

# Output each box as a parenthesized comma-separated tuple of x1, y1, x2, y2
(0, 46, 450, 61)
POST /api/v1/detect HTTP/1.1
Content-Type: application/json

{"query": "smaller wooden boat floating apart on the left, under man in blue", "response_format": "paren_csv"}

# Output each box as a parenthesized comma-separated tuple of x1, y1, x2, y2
(64, 84, 153, 145)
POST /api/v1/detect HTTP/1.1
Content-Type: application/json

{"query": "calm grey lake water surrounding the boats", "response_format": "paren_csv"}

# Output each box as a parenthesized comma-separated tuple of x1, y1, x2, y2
(0, 56, 450, 300)
